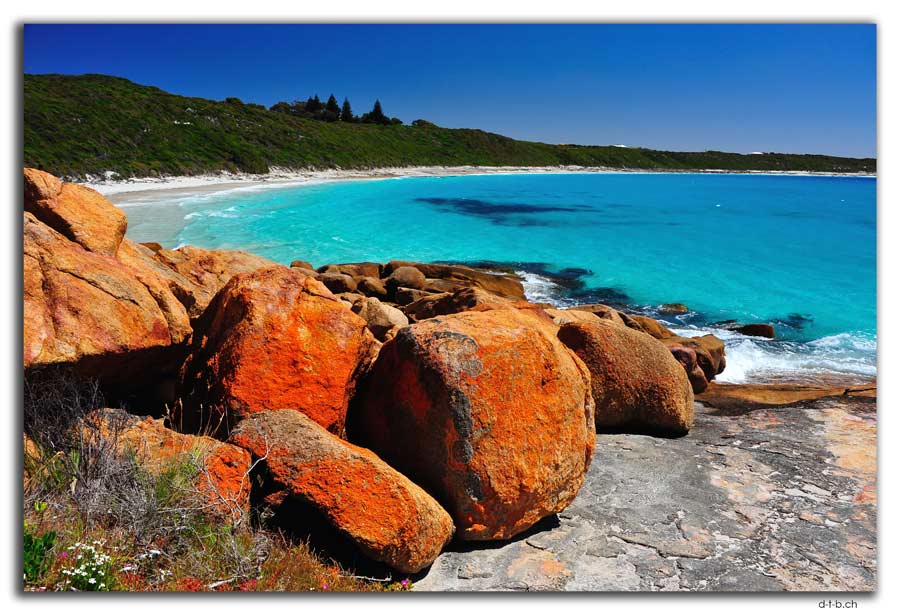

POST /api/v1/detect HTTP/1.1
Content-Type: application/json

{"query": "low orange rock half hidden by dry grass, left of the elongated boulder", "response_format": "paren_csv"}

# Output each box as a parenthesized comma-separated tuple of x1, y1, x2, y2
(81, 408, 250, 524)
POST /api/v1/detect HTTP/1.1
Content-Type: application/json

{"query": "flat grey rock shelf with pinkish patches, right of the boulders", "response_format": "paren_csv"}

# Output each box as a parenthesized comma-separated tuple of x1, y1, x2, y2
(414, 397, 876, 591)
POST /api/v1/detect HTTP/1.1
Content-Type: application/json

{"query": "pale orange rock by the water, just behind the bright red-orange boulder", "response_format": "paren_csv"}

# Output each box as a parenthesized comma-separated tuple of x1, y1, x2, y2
(143, 244, 276, 319)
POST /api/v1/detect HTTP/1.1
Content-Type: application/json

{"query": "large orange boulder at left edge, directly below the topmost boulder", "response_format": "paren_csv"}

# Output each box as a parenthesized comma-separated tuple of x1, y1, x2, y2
(23, 213, 191, 376)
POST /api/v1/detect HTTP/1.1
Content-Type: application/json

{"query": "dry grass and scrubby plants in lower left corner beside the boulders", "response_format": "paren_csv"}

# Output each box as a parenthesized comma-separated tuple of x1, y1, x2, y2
(23, 373, 408, 592)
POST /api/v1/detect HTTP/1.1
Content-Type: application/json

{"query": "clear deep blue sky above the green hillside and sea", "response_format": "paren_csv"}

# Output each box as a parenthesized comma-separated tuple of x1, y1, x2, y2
(23, 24, 876, 156)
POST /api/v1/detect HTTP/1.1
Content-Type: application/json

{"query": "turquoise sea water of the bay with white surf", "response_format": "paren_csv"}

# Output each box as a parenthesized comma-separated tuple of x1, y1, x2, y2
(128, 173, 876, 382)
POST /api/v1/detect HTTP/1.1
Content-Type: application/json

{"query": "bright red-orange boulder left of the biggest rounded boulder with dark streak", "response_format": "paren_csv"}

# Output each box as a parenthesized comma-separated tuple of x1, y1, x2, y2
(181, 265, 378, 434)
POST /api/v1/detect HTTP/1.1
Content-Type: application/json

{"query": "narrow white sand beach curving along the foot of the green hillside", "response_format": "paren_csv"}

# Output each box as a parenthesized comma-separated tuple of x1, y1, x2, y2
(88, 166, 877, 205)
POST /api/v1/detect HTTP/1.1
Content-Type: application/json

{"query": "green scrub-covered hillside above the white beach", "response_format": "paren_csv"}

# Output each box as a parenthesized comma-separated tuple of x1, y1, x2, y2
(24, 75, 875, 177)
